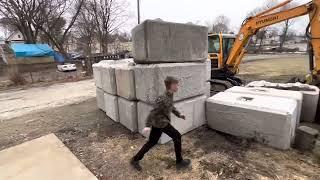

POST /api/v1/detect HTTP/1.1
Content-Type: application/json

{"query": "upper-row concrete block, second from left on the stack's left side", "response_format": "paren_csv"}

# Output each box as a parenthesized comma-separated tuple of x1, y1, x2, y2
(99, 59, 133, 95)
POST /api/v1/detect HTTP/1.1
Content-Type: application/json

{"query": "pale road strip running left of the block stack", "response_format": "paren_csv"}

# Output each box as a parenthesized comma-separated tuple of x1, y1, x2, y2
(0, 80, 96, 121)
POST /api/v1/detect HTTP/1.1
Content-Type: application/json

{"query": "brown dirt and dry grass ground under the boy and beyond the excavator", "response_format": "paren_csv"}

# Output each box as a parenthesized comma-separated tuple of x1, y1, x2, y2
(0, 57, 320, 180)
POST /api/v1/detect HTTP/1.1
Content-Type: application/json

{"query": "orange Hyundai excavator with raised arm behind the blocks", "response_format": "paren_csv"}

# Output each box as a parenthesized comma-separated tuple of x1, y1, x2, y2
(208, 0, 320, 91)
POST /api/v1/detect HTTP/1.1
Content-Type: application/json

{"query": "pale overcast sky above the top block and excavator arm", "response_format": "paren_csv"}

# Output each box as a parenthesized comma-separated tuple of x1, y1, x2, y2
(127, 0, 310, 32)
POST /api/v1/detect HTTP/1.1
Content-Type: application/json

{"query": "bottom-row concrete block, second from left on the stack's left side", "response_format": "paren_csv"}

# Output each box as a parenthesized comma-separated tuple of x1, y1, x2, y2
(104, 93, 119, 122)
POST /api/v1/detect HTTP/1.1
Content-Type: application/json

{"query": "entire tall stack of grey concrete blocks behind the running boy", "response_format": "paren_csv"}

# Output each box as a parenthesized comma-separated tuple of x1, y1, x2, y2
(93, 20, 211, 138)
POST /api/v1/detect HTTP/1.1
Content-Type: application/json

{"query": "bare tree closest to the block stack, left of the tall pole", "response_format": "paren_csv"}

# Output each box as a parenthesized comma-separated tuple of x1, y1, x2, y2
(90, 0, 129, 54)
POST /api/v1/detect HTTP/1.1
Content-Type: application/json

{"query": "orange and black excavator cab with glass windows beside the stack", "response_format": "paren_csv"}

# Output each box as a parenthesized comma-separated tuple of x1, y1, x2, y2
(208, 33, 236, 69)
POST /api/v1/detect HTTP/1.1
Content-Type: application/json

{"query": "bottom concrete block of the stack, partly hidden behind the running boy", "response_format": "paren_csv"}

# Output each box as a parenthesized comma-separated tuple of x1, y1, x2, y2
(138, 95, 206, 144)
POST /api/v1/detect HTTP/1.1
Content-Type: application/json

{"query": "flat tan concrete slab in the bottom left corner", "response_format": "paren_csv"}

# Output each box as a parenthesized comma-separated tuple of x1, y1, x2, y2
(0, 134, 97, 180)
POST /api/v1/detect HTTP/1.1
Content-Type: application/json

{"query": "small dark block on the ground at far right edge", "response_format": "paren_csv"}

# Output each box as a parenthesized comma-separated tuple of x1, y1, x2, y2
(294, 126, 319, 151)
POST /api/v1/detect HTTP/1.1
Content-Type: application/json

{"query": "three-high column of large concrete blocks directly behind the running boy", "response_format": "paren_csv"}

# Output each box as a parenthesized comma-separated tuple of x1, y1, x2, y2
(131, 20, 211, 143)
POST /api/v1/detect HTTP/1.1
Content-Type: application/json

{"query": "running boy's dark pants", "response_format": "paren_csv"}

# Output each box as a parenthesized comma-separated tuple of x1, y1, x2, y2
(133, 124, 182, 163)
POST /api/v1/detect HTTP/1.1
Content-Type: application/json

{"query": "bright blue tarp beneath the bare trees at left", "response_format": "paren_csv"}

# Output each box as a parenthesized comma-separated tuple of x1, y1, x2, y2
(11, 43, 54, 57)
